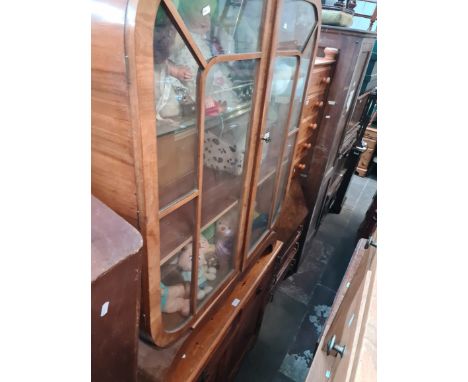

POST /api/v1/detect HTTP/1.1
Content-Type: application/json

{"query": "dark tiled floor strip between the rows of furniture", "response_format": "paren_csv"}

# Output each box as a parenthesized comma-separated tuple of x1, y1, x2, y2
(236, 174, 377, 382)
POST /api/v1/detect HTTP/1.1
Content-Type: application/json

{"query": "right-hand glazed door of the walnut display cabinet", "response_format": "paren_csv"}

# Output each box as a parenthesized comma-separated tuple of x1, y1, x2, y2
(247, 0, 317, 255)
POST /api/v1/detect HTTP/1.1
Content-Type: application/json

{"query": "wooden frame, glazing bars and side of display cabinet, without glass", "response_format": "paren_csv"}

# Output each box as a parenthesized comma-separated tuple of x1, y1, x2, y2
(92, 0, 321, 346)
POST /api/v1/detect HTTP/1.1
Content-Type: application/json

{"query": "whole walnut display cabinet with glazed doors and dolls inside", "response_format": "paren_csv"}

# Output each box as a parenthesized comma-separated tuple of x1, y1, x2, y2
(92, 0, 321, 347)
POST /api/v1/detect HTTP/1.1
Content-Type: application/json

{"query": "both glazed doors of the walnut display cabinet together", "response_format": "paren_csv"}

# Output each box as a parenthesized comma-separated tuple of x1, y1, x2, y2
(152, 0, 317, 338)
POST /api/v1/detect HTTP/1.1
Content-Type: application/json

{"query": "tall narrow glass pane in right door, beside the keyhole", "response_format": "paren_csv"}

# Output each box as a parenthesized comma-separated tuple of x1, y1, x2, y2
(250, 57, 297, 249)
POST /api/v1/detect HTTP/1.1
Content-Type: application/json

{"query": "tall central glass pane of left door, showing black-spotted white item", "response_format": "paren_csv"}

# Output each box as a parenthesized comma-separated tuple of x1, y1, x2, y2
(197, 60, 257, 306)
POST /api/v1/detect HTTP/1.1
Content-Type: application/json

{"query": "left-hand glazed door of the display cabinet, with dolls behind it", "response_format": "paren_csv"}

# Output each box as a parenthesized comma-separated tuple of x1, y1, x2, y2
(153, 0, 266, 332)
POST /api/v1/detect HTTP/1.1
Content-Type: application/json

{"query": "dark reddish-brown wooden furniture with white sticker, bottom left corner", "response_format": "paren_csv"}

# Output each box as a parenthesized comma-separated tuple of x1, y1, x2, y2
(91, 197, 143, 382)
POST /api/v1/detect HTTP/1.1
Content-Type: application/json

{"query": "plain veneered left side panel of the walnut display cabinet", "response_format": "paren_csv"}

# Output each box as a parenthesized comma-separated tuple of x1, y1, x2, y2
(91, 0, 137, 226)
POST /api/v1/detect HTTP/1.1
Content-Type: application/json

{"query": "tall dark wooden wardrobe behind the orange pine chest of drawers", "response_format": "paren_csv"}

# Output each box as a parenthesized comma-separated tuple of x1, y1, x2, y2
(307, 26, 376, 236)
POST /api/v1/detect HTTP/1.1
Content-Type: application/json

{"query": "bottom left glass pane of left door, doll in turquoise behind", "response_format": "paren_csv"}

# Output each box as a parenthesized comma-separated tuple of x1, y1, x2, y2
(160, 200, 195, 331)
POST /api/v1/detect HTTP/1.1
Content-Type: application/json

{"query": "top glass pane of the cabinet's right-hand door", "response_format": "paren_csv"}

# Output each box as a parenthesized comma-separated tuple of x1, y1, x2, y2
(278, 0, 317, 51)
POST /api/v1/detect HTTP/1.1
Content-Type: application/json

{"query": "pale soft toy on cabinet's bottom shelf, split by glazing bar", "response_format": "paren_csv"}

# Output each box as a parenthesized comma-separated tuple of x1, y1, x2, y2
(177, 243, 216, 300)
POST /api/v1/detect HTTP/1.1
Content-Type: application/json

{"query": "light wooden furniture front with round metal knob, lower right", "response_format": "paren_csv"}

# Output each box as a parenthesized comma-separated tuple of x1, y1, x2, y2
(306, 239, 377, 382)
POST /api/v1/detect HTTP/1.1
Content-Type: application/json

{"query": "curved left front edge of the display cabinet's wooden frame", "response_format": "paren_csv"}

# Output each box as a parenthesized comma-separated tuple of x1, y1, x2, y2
(124, 0, 170, 346)
